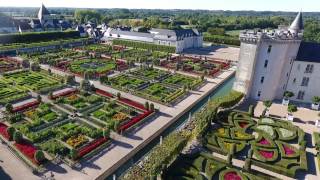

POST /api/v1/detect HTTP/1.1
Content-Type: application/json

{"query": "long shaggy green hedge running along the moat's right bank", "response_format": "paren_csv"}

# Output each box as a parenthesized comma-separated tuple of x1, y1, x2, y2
(123, 91, 243, 179)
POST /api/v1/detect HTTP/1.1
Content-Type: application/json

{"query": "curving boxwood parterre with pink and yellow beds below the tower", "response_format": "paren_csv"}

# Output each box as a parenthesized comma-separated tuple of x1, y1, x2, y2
(204, 111, 308, 178)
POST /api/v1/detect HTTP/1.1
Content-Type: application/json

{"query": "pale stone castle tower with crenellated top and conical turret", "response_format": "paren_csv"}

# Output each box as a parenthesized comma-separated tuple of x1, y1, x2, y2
(233, 12, 303, 100)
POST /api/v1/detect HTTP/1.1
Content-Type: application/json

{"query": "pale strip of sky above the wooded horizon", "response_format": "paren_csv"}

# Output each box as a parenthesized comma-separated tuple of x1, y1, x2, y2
(0, 0, 320, 12)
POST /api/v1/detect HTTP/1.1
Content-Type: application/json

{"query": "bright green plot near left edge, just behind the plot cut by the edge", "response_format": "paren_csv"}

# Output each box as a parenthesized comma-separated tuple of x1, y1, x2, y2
(3, 70, 62, 92)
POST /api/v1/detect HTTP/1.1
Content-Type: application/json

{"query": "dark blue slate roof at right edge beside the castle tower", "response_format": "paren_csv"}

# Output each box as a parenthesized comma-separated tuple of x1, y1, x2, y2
(296, 42, 320, 63)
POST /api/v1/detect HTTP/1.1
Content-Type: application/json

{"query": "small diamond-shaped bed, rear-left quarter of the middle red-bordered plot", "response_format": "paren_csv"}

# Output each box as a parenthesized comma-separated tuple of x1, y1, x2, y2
(56, 92, 103, 113)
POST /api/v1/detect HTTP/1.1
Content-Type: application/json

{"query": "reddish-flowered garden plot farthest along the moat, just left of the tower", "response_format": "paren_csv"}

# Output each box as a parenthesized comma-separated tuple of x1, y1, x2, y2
(160, 56, 230, 77)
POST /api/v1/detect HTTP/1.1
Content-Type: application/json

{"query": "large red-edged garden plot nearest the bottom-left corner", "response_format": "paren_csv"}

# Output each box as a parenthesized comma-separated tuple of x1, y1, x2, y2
(12, 104, 108, 160)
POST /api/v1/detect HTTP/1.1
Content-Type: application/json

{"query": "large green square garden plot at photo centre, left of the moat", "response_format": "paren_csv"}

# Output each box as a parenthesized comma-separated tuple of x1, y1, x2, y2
(100, 67, 204, 105)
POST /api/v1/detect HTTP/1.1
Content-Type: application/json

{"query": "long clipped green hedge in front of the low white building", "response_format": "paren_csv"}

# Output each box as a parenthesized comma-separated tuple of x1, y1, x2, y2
(112, 39, 176, 53)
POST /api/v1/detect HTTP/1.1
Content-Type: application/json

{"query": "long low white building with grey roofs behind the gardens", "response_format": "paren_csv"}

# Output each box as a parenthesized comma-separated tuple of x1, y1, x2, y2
(104, 28, 203, 53)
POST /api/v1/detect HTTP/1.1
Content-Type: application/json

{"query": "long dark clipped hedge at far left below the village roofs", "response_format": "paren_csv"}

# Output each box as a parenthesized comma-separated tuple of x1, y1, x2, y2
(0, 31, 80, 44)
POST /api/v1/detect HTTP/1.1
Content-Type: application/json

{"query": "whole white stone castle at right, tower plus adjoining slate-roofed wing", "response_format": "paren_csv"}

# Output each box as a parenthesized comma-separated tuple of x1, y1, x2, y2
(233, 13, 320, 102)
